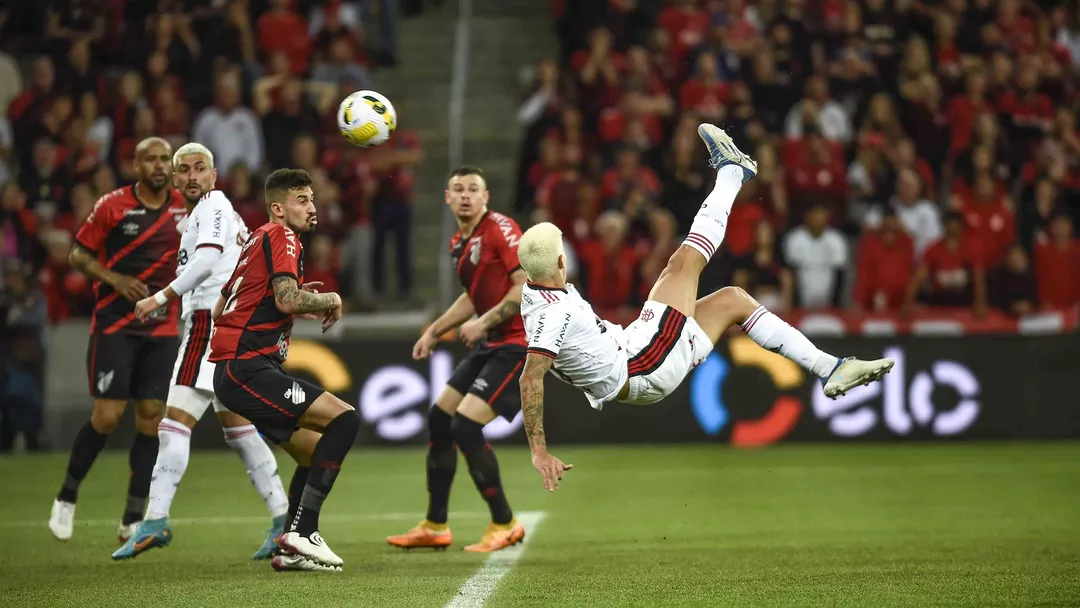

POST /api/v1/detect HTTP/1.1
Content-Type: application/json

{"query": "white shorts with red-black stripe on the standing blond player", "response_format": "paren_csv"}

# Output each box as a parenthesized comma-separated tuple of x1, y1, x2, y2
(165, 310, 221, 420)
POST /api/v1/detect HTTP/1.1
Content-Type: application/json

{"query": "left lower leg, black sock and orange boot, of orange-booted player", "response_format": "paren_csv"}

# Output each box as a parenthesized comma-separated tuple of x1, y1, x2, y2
(387, 395, 462, 549)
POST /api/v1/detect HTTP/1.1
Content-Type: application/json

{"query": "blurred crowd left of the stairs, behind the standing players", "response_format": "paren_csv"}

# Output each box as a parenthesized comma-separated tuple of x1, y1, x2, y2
(0, 0, 421, 322)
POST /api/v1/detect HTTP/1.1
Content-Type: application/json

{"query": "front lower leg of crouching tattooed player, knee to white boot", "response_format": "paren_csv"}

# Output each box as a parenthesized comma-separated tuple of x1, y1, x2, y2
(278, 392, 360, 567)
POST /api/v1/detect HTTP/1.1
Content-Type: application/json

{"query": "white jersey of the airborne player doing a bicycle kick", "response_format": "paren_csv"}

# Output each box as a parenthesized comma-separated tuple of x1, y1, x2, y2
(522, 283, 627, 409)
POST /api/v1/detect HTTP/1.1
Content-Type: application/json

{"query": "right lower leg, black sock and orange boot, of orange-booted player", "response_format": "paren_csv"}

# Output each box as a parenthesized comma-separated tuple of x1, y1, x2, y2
(450, 394, 525, 553)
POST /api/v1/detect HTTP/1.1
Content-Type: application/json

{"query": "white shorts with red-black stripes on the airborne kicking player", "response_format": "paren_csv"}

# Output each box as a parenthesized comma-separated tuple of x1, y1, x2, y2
(623, 300, 713, 405)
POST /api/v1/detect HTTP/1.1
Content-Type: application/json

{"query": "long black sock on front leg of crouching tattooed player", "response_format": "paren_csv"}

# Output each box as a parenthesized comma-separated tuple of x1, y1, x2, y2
(289, 411, 360, 537)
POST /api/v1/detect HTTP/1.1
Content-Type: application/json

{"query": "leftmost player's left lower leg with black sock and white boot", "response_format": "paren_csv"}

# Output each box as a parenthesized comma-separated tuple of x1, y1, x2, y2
(49, 398, 127, 540)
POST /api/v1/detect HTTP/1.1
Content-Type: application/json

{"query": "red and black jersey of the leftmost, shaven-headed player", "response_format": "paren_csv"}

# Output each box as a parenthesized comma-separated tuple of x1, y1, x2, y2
(75, 186, 188, 337)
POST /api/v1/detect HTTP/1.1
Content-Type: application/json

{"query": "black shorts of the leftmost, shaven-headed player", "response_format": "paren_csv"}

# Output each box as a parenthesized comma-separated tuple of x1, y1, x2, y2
(86, 332, 179, 401)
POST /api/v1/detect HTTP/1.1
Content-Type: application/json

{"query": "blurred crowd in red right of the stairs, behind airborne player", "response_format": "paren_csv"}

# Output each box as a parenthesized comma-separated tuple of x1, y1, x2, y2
(517, 0, 1080, 328)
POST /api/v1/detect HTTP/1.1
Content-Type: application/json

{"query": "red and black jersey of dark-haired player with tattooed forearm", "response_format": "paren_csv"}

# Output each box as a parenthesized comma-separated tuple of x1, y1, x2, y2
(210, 221, 303, 363)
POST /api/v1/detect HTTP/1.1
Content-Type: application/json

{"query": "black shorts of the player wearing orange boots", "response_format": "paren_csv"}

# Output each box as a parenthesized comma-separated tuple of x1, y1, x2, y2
(446, 344, 525, 420)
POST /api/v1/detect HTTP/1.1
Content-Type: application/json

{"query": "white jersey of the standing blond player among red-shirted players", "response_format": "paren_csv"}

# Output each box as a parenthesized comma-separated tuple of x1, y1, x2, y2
(176, 190, 248, 320)
